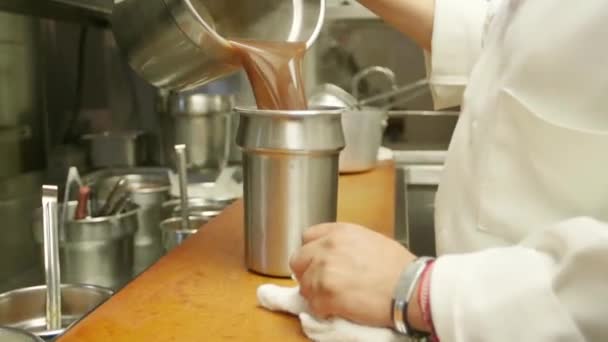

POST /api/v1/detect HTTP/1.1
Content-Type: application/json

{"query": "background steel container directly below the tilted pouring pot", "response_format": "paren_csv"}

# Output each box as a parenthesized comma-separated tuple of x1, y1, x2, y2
(161, 93, 234, 179)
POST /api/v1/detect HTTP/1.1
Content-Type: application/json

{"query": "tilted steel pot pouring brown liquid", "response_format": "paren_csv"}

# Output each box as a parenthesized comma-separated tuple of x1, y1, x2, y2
(112, 0, 325, 90)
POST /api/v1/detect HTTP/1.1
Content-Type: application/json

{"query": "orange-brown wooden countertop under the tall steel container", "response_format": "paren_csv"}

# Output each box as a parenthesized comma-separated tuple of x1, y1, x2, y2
(60, 162, 395, 342)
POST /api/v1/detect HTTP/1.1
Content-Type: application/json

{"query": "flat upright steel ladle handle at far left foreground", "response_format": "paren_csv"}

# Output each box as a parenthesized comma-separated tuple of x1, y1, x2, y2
(42, 185, 61, 330)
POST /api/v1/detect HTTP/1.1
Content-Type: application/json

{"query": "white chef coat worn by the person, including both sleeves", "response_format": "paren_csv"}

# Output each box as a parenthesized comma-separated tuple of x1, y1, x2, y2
(427, 0, 608, 342)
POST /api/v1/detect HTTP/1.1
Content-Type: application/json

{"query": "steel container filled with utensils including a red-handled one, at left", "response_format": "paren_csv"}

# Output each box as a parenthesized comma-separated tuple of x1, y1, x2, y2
(33, 202, 139, 289)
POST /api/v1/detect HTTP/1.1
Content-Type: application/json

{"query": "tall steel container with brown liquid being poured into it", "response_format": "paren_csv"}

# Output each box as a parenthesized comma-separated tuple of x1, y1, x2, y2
(237, 108, 344, 277)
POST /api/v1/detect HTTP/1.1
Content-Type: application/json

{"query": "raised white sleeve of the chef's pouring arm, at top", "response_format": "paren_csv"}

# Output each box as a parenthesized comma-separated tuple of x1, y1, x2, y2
(425, 0, 493, 109)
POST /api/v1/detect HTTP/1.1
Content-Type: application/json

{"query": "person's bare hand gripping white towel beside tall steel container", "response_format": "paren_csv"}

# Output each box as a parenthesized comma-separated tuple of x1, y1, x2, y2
(291, 223, 415, 327)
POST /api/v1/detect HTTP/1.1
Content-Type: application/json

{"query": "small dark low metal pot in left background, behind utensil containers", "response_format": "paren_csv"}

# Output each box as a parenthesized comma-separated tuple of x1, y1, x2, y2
(82, 131, 146, 169)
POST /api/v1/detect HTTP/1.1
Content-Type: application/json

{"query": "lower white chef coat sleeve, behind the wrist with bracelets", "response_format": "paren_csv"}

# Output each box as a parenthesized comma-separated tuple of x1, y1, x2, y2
(431, 218, 608, 342)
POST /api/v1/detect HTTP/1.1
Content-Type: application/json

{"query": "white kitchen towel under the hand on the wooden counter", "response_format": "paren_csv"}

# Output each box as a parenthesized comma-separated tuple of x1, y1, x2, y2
(258, 284, 409, 342)
